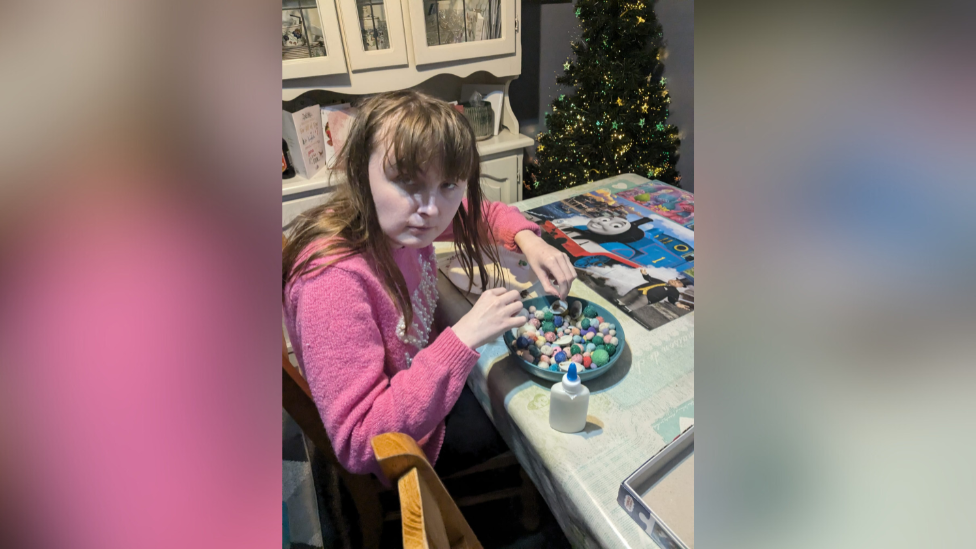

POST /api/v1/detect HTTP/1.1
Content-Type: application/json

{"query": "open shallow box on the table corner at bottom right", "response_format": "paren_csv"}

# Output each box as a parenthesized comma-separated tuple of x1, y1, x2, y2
(617, 425, 695, 549)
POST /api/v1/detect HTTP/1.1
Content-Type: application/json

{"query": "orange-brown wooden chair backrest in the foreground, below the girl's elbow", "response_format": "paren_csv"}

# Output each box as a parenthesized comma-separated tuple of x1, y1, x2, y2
(371, 433, 481, 549)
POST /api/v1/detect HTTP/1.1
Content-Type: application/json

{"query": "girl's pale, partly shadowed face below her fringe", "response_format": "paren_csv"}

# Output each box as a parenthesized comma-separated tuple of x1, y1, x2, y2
(369, 137, 467, 248)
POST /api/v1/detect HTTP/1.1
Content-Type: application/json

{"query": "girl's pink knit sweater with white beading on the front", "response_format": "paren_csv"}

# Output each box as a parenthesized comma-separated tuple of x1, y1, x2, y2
(284, 202, 539, 479)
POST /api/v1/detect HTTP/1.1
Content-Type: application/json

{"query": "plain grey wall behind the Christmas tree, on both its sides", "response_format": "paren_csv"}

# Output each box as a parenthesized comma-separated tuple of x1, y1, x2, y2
(509, 0, 695, 192)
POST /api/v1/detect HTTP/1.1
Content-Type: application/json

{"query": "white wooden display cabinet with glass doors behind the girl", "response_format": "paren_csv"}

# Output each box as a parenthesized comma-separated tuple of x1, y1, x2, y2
(281, 0, 534, 226)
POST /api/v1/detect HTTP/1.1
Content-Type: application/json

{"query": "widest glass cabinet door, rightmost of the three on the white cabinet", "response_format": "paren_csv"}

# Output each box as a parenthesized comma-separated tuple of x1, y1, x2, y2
(408, 0, 516, 65)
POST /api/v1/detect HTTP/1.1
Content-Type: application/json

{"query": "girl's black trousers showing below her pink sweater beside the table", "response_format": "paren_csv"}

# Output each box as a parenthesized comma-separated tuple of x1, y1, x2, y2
(434, 385, 508, 478)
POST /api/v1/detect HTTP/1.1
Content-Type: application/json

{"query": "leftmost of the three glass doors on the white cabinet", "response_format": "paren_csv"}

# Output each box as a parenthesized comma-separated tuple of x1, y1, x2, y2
(281, 0, 346, 79)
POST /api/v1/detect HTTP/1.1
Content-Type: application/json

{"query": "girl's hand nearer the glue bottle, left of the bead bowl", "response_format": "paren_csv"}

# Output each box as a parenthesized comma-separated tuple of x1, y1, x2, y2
(452, 288, 529, 349)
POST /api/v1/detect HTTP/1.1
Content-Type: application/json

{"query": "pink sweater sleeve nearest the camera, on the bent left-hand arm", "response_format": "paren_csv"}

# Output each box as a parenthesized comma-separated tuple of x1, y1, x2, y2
(295, 267, 480, 478)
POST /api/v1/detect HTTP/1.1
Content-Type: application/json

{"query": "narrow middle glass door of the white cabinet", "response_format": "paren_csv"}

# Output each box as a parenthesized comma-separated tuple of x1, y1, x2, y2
(339, 0, 407, 71)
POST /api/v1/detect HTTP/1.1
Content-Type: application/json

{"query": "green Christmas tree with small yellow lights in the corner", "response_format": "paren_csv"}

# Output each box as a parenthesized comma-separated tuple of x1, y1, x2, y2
(525, 0, 681, 195)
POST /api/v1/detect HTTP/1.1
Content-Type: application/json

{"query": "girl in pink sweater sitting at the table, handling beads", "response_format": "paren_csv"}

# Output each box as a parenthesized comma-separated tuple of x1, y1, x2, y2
(282, 91, 576, 479)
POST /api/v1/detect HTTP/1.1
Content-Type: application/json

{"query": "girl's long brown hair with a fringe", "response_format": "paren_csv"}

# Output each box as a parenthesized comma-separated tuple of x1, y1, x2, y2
(281, 90, 502, 326)
